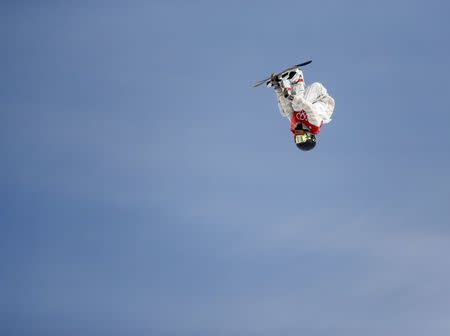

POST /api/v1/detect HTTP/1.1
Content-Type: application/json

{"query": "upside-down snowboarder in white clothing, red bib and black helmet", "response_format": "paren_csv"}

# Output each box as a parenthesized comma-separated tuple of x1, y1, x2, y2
(267, 67, 335, 151)
